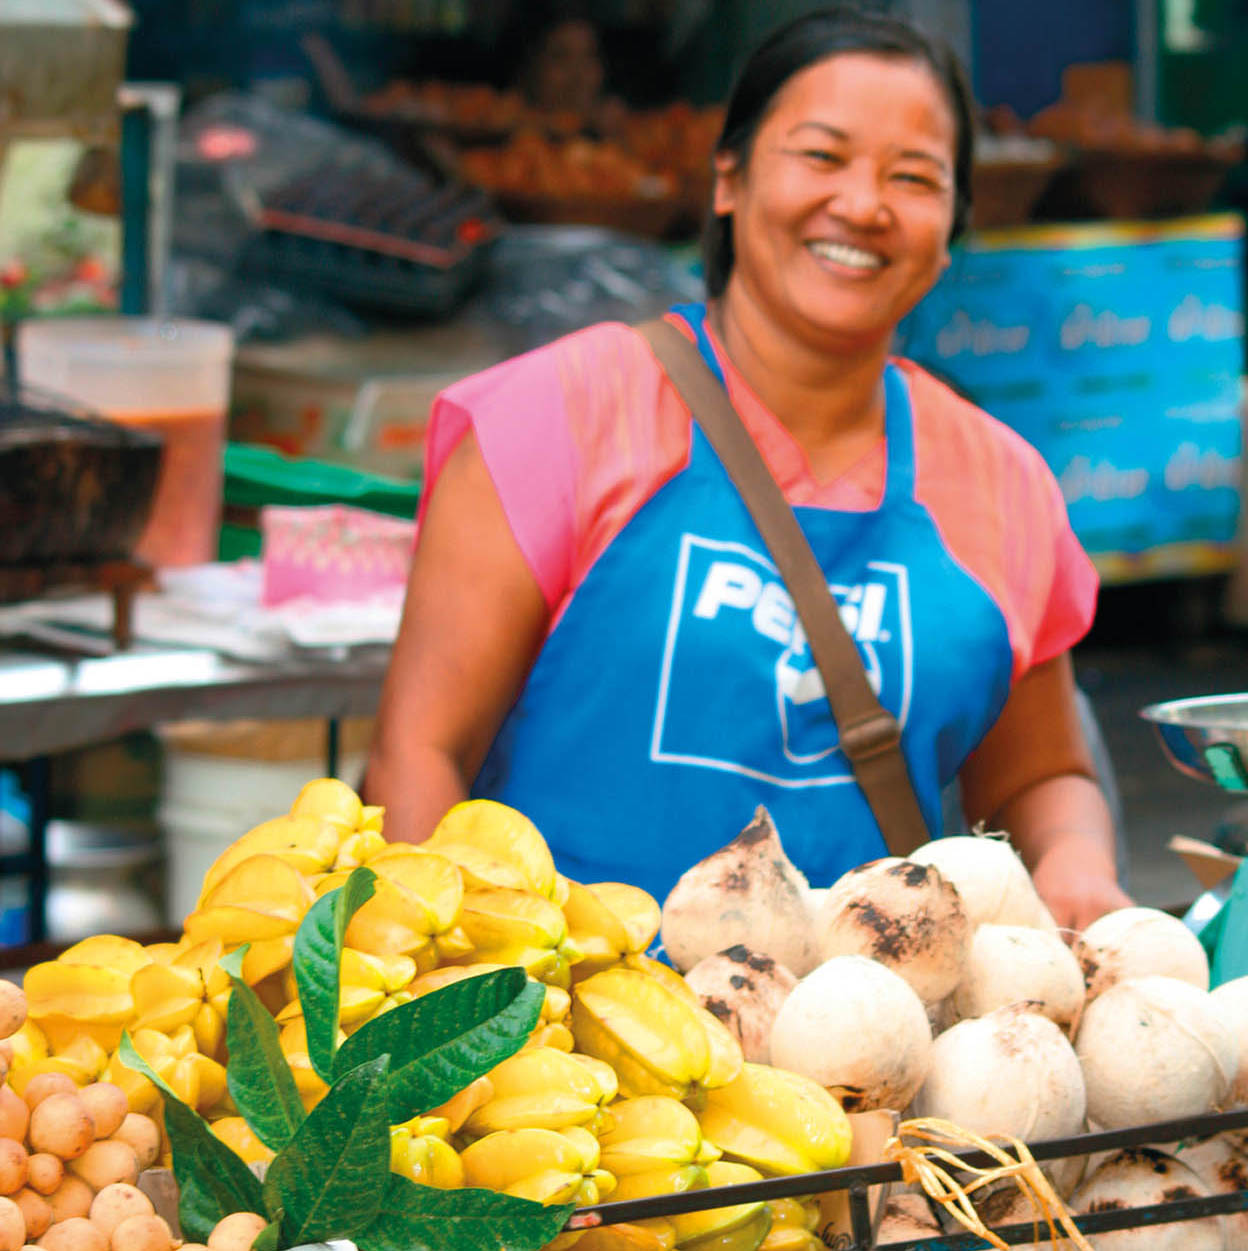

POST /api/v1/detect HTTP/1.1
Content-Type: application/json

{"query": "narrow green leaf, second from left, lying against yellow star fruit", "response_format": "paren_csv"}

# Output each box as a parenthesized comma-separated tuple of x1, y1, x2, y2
(219, 943, 306, 1151)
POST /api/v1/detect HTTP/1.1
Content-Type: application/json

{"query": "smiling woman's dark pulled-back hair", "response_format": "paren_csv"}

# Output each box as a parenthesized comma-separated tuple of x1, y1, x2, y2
(702, 5, 975, 299)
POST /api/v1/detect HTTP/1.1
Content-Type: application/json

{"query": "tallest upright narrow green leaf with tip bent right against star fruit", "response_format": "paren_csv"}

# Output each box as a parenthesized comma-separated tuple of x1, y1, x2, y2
(294, 867, 376, 1082)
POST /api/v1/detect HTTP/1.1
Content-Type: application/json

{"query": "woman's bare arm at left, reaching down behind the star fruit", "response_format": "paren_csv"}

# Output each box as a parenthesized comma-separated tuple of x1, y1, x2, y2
(363, 433, 549, 842)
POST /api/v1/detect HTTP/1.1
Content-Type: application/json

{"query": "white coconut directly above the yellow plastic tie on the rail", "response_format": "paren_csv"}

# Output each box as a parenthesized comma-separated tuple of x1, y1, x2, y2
(914, 1003, 1085, 1141)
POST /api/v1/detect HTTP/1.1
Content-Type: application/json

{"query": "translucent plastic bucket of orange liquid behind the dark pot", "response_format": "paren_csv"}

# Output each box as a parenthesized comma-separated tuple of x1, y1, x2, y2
(18, 317, 234, 567)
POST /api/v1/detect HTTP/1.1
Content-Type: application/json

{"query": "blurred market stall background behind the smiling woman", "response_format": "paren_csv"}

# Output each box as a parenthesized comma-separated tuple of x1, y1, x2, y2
(0, 0, 1248, 945)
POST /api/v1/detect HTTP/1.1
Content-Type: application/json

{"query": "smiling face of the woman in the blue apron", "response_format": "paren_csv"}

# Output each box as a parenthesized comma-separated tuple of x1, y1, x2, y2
(714, 53, 957, 347)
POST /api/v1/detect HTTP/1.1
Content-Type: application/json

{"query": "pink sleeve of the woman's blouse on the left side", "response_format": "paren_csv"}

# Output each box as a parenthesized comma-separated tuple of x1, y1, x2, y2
(420, 348, 576, 604)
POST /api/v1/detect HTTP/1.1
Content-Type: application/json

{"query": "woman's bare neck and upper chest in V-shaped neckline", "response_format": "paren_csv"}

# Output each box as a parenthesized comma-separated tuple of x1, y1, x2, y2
(709, 281, 889, 467)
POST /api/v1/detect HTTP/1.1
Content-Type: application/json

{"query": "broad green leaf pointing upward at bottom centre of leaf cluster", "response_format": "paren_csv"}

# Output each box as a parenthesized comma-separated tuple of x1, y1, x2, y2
(264, 1056, 390, 1246)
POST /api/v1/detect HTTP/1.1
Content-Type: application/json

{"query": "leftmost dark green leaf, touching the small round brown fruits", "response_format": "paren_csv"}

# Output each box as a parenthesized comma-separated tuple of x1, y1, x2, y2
(118, 1033, 265, 1242)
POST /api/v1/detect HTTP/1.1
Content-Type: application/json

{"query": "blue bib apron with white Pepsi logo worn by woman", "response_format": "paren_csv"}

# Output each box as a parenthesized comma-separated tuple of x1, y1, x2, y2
(473, 305, 1012, 902)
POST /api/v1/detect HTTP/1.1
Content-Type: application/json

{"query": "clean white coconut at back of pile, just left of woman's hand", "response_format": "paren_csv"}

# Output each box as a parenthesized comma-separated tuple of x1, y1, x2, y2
(909, 834, 1057, 929)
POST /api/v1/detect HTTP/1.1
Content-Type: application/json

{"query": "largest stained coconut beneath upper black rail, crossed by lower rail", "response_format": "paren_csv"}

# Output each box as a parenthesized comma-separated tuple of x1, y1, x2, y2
(1070, 1147, 1229, 1251)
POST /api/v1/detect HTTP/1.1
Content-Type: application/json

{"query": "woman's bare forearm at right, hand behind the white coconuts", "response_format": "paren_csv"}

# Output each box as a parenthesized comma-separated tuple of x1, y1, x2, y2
(962, 653, 1130, 929)
